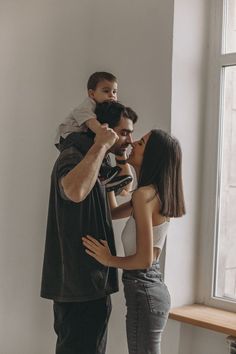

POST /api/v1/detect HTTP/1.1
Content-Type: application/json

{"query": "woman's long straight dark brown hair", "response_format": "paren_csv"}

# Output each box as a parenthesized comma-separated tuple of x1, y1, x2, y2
(138, 129, 186, 217)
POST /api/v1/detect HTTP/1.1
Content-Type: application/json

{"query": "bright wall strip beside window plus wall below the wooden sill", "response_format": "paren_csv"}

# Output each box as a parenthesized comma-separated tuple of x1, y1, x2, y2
(162, 0, 227, 354)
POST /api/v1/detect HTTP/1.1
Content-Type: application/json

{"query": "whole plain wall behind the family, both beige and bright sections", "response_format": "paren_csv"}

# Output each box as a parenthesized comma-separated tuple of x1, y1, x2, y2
(0, 0, 231, 354)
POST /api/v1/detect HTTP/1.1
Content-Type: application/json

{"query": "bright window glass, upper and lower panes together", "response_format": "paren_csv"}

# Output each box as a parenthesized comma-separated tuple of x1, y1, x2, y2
(213, 0, 236, 300)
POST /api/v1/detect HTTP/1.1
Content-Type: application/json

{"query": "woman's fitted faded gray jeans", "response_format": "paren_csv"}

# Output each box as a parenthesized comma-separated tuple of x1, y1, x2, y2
(122, 262, 170, 354)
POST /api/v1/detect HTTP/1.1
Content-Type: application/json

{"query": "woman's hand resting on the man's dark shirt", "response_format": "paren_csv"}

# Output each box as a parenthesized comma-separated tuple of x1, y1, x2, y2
(82, 235, 112, 267)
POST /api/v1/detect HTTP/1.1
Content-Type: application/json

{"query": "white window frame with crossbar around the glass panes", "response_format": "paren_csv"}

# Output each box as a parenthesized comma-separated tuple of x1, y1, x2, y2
(198, 0, 236, 312)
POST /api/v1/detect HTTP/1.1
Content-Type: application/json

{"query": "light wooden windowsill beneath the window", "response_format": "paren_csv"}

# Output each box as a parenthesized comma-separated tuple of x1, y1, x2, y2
(169, 304, 236, 337)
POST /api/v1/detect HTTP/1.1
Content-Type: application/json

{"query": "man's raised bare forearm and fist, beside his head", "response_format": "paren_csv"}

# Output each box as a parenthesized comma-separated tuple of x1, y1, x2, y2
(61, 125, 118, 203)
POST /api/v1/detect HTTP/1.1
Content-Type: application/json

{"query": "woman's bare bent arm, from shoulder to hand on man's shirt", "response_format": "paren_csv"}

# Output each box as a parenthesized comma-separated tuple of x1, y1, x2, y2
(83, 188, 153, 269)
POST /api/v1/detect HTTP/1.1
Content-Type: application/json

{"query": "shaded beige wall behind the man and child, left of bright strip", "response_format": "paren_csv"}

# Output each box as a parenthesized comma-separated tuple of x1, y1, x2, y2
(0, 0, 173, 354)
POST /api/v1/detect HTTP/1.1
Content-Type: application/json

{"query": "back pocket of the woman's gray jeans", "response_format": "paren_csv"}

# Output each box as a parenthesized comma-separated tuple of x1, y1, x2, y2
(144, 282, 170, 317)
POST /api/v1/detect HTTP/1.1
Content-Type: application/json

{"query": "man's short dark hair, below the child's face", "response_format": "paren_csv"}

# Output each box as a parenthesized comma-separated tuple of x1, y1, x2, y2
(95, 101, 138, 128)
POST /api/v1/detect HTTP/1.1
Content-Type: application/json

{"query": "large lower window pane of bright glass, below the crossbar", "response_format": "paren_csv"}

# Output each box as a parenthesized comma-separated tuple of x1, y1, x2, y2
(214, 66, 236, 300)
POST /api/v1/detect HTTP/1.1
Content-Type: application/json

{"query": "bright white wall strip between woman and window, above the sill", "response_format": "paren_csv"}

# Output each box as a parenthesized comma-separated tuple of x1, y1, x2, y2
(166, 0, 209, 307)
